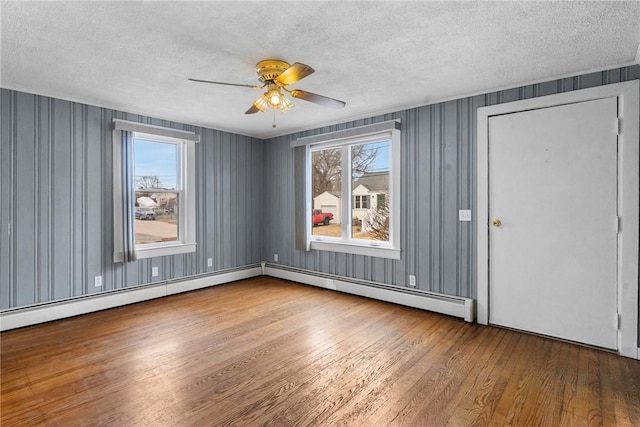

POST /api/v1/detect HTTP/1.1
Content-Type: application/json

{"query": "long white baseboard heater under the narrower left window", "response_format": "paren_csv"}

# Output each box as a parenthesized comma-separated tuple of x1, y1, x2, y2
(0, 265, 262, 331)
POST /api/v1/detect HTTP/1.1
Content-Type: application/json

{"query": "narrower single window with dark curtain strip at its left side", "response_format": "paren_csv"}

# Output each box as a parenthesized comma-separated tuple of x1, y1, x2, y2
(114, 121, 196, 262)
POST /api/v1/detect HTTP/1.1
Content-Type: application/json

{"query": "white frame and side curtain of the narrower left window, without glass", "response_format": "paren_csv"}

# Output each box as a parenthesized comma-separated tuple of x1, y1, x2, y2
(113, 120, 197, 262)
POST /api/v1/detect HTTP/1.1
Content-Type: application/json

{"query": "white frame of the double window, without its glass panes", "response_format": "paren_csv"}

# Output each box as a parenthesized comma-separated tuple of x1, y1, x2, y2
(305, 121, 401, 259)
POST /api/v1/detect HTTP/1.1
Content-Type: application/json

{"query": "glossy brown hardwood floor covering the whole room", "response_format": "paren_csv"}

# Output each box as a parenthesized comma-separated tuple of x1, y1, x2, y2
(0, 277, 640, 427)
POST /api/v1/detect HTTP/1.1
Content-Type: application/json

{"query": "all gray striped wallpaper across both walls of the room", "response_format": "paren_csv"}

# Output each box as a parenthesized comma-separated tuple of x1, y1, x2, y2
(0, 65, 640, 318)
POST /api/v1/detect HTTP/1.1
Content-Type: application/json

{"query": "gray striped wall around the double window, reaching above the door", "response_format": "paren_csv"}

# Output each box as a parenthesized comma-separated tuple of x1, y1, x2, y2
(263, 65, 640, 298)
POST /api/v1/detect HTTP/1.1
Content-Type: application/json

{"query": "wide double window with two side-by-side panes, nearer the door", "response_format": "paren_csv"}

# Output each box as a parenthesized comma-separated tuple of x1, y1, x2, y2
(296, 121, 400, 259)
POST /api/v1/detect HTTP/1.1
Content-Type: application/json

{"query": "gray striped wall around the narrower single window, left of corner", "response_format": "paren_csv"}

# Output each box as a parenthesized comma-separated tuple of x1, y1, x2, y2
(0, 89, 264, 308)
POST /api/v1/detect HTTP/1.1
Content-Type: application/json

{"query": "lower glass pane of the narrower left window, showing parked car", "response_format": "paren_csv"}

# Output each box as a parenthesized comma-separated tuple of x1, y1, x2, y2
(135, 191, 180, 245)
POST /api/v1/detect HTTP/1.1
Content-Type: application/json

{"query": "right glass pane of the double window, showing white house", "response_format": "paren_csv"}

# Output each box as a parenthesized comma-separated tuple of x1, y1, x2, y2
(351, 142, 389, 242)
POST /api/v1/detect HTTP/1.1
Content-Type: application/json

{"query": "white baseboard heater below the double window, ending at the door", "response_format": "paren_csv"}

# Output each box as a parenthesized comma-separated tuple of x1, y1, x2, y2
(262, 263, 475, 322)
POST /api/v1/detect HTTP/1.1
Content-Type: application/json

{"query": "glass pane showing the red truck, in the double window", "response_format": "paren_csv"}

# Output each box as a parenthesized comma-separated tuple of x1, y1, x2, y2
(311, 148, 342, 237)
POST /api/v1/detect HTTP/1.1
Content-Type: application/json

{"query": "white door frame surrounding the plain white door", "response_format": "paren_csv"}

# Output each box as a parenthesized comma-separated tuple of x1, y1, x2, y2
(476, 80, 640, 359)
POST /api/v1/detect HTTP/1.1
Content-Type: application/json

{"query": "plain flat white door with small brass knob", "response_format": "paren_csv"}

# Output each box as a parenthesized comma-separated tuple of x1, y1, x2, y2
(488, 97, 618, 349)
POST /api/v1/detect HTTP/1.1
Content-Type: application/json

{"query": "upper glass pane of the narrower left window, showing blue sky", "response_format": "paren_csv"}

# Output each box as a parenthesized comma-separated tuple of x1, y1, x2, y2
(135, 138, 179, 190)
